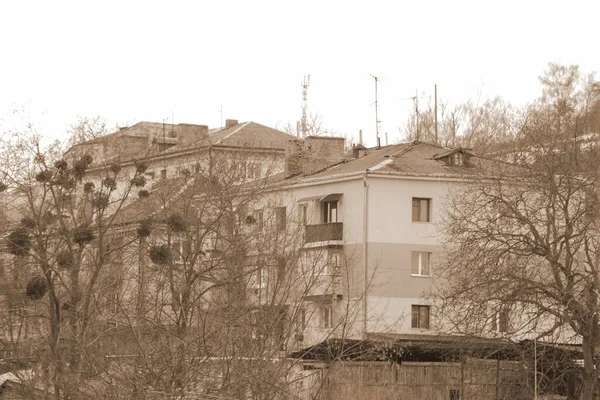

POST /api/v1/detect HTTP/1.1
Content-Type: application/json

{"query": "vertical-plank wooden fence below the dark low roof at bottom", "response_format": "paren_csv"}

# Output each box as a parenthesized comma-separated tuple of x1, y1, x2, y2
(301, 359, 533, 400)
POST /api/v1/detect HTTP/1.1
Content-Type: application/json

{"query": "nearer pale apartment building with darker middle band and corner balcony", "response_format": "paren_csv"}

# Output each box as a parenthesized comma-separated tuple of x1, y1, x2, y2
(268, 139, 474, 344)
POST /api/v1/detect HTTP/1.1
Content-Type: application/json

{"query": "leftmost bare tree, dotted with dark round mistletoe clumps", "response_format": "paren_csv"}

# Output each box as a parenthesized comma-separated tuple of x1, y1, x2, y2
(0, 123, 150, 399)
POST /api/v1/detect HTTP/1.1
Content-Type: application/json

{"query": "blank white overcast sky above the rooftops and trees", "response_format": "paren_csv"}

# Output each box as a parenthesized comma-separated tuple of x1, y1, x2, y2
(0, 0, 600, 145)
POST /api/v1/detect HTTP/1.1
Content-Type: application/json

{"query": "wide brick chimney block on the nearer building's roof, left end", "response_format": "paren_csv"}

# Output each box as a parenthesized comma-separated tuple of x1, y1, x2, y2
(285, 136, 345, 177)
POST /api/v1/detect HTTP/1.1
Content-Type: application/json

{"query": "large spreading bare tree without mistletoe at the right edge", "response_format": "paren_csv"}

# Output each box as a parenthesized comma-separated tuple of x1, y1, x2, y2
(438, 66, 600, 399)
